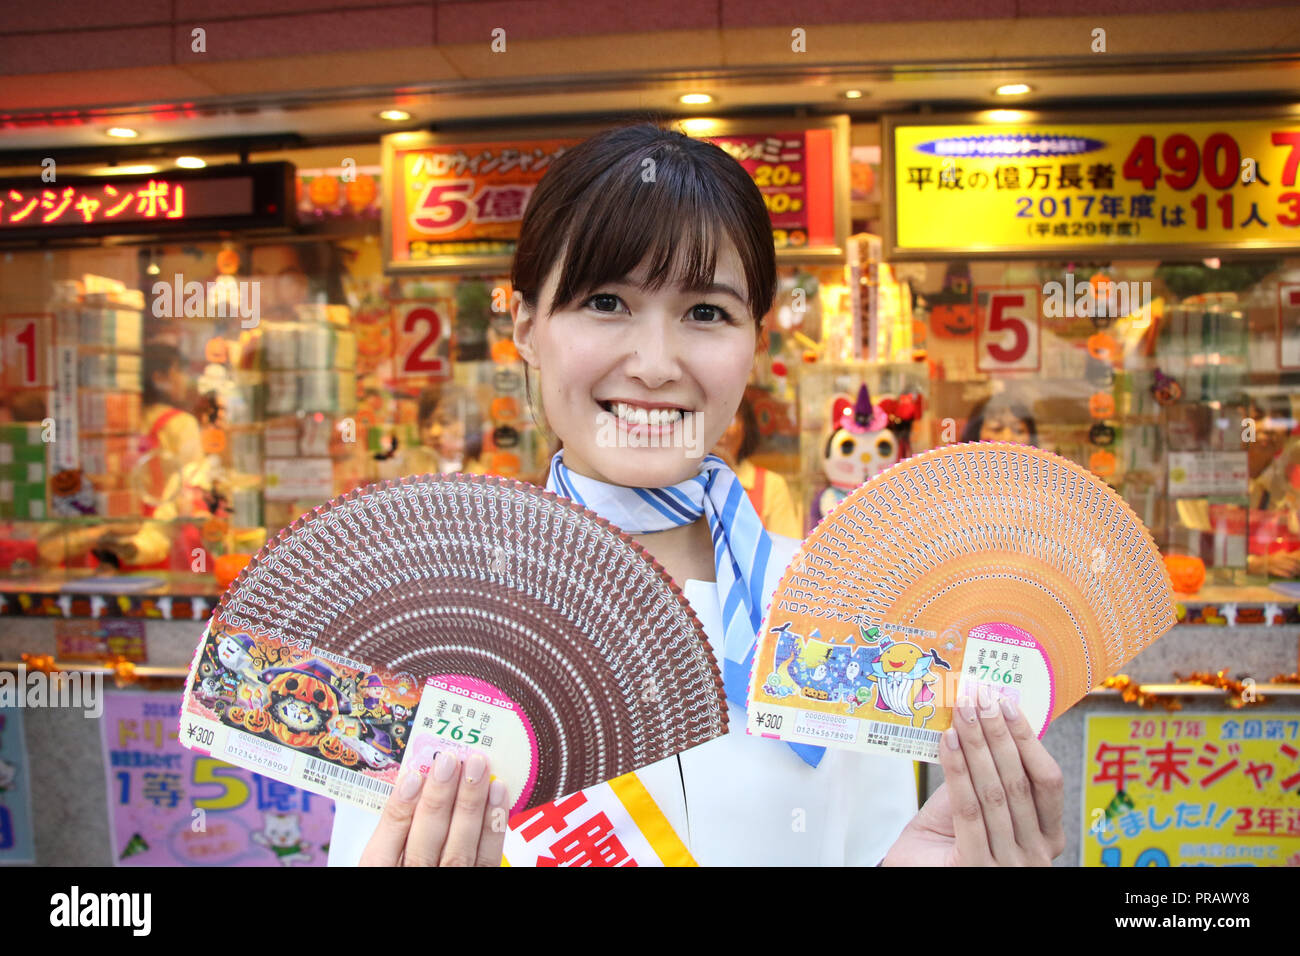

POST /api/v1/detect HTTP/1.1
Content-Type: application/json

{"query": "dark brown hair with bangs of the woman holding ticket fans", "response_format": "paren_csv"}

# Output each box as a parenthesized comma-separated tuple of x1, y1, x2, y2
(510, 122, 776, 463)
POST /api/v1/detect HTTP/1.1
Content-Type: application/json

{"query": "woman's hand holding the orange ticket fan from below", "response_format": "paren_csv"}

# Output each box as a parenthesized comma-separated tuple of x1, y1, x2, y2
(883, 688, 1065, 866)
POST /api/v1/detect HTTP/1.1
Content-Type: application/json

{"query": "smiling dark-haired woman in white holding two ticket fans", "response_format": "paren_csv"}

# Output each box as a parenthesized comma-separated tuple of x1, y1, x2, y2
(330, 125, 1065, 865)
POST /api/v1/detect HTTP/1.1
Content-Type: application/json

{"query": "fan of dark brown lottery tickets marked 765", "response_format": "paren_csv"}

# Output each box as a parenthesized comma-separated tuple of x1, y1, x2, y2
(181, 473, 727, 814)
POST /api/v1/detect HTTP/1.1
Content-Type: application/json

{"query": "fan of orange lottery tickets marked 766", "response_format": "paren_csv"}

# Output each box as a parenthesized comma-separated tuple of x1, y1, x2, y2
(748, 442, 1175, 762)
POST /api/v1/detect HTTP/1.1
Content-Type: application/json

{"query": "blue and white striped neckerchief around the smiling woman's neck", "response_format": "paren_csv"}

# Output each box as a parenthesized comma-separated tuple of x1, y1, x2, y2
(546, 449, 826, 767)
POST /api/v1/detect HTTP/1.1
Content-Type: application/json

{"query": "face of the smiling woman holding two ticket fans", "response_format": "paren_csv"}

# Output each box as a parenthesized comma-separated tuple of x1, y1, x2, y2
(511, 231, 757, 488)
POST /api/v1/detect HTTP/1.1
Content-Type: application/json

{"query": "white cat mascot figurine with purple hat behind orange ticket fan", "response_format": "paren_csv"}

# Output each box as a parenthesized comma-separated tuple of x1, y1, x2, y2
(810, 385, 920, 528)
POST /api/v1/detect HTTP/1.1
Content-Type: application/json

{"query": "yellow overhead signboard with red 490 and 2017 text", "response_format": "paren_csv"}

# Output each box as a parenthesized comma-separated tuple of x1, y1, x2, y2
(887, 116, 1300, 258)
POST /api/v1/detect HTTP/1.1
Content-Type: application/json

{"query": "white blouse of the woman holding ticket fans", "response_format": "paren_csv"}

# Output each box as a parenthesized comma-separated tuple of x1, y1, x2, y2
(329, 535, 917, 866)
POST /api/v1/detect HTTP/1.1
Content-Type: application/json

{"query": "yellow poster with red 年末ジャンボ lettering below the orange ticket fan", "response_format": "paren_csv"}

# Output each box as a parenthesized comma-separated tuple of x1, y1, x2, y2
(1083, 710, 1300, 866)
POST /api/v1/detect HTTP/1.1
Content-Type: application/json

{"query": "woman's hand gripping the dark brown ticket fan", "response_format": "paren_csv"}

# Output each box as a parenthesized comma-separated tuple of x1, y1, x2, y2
(358, 750, 508, 866)
